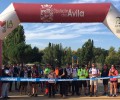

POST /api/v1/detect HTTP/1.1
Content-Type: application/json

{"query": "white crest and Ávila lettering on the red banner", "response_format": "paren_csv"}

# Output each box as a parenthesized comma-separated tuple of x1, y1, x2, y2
(40, 4, 85, 22)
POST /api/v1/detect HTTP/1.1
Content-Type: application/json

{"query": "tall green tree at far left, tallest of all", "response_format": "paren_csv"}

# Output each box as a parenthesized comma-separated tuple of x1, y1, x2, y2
(3, 25, 25, 63)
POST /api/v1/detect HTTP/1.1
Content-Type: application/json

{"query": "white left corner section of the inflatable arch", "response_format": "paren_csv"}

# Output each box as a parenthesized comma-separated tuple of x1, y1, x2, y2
(0, 4, 20, 40)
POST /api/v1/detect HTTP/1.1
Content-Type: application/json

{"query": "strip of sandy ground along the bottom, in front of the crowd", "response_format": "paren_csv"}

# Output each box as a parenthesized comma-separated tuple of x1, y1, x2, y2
(10, 95, 120, 100)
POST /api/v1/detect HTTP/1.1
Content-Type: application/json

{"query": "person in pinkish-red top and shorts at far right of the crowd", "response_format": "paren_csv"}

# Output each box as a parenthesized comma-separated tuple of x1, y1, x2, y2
(109, 65, 118, 97)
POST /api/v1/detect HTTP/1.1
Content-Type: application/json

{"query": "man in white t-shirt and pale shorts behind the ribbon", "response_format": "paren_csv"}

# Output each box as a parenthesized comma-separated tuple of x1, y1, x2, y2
(89, 63, 100, 96)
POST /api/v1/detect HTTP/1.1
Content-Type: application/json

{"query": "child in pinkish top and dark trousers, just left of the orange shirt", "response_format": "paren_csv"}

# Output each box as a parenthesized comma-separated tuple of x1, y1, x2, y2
(48, 68, 56, 97)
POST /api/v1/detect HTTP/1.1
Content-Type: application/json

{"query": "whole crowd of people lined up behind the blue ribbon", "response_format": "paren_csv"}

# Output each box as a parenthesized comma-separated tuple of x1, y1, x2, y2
(1, 63, 119, 98)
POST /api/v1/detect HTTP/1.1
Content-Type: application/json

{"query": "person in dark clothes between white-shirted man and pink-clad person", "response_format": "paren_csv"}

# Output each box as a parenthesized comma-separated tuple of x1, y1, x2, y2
(101, 65, 109, 96)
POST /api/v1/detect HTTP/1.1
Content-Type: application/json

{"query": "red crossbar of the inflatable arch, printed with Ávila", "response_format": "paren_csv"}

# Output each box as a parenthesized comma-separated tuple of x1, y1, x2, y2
(13, 3, 111, 23)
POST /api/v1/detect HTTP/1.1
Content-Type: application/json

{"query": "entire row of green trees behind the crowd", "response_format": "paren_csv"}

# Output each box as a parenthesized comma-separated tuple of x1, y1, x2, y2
(2, 25, 120, 66)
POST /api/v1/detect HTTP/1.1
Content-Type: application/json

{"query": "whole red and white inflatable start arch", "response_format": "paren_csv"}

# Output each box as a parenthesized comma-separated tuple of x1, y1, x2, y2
(0, 3, 120, 94)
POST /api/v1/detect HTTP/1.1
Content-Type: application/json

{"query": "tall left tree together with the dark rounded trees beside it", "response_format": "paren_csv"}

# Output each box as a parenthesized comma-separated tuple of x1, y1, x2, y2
(3, 25, 43, 63)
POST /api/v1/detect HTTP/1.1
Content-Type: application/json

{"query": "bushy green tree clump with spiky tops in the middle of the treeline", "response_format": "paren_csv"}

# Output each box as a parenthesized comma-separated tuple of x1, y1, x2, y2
(43, 43, 63, 66)
